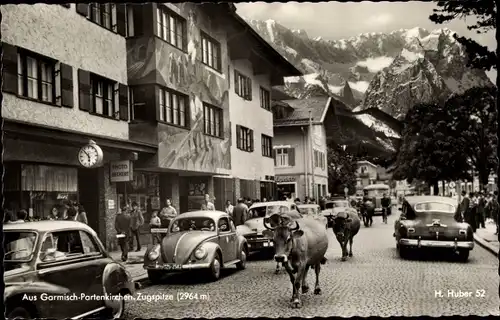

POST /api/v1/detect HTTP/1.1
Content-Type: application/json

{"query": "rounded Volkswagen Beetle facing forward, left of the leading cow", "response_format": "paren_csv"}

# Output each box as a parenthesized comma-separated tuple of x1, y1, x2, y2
(144, 210, 248, 283)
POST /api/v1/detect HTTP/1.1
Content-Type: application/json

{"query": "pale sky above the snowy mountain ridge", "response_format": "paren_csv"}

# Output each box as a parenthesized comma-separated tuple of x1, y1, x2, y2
(236, 1, 497, 82)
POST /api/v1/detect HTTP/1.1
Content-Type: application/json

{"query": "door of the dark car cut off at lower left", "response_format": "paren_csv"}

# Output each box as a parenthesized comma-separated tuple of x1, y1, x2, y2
(37, 230, 95, 318)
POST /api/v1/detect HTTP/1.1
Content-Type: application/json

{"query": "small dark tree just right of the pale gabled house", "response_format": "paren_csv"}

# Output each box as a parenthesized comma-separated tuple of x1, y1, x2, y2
(327, 142, 357, 194)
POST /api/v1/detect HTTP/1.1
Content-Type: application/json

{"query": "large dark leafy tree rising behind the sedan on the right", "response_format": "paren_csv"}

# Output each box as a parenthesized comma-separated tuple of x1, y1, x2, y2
(393, 104, 470, 195)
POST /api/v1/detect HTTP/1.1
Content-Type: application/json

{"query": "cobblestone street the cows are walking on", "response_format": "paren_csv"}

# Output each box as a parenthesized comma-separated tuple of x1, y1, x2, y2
(126, 214, 499, 319)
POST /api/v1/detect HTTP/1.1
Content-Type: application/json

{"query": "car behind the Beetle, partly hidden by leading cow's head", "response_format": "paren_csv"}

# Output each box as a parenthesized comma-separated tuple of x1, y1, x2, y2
(237, 201, 302, 252)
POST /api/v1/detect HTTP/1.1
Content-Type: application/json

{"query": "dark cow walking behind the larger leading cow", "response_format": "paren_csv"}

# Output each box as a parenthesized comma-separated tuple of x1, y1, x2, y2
(332, 211, 361, 261)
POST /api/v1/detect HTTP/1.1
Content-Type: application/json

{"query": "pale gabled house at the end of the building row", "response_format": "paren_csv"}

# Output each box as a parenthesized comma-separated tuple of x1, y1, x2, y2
(273, 97, 331, 200)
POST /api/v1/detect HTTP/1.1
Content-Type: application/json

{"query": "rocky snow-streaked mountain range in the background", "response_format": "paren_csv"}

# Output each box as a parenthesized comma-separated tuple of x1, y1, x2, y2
(247, 19, 493, 119)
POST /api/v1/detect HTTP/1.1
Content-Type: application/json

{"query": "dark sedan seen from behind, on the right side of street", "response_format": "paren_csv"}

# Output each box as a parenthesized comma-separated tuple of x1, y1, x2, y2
(394, 196, 474, 262)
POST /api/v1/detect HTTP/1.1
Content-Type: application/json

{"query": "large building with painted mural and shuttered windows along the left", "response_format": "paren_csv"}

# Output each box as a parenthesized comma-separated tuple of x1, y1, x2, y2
(1, 3, 300, 249)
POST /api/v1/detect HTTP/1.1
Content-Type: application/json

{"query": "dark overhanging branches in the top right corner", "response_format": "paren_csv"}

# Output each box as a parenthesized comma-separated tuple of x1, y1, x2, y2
(429, 0, 498, 70)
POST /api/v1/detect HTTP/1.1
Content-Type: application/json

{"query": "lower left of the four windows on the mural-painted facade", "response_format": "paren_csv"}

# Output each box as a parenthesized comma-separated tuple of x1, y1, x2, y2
(159, 88, 189, 128)
